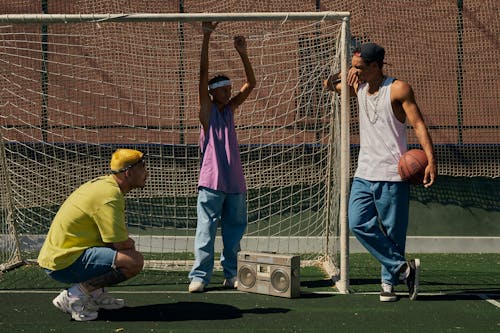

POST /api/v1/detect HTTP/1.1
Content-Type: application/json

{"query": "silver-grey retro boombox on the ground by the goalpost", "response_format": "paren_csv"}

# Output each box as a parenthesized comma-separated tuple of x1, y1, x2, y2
(238, 251, 300, 298)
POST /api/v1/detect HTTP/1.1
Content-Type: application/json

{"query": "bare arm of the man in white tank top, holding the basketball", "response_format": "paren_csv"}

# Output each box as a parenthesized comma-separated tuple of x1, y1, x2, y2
(391, 80, 437, 187)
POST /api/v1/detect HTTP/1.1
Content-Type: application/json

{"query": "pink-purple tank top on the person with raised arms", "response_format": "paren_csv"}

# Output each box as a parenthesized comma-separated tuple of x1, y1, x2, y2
(198, 104, 247, 194)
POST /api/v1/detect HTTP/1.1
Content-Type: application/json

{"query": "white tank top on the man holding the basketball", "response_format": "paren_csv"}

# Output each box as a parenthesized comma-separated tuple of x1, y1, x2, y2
(354, 77, 408, 182)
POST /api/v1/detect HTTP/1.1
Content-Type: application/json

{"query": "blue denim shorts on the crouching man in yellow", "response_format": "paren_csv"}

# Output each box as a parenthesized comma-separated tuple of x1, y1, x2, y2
(45, 247, 116, 283)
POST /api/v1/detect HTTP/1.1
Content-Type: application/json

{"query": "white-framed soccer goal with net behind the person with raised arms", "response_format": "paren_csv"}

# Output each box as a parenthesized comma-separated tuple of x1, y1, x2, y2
(0, 12, 350, 291)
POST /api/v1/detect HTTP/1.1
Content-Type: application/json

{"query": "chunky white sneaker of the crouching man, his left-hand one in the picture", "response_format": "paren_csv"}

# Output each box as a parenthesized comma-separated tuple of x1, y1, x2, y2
(52, 290, 99, 321)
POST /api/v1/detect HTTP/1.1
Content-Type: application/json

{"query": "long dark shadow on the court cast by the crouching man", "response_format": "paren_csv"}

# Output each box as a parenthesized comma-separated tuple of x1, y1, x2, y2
(97, 302, 290, 321)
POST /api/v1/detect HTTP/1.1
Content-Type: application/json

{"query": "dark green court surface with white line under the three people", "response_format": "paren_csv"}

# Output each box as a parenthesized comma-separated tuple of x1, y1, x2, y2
(0, 254, 500, 333)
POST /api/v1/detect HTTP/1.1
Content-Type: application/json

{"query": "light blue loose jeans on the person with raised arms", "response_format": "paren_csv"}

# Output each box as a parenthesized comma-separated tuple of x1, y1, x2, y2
(189, 187, 247, 285)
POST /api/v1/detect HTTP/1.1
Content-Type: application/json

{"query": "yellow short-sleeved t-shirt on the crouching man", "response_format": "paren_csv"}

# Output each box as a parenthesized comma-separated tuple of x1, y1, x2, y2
(38, 175, 128, 270)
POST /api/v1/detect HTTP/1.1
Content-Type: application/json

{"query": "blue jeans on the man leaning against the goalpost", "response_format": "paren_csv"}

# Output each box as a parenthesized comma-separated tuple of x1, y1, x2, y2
(349, 178, 410, 286)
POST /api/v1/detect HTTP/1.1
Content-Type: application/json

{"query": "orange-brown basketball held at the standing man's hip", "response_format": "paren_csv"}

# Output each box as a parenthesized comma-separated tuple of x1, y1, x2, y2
(398, 149, 427, 185)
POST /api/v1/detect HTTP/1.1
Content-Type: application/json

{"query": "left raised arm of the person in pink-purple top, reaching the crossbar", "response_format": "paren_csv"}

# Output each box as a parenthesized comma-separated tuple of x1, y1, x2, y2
(198, 22, 218, 131)
